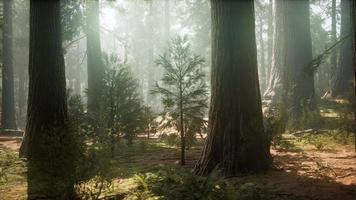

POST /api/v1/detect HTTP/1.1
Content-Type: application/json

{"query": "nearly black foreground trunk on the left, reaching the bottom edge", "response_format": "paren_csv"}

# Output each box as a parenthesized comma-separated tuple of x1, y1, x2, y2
(21, 0, 75, 199)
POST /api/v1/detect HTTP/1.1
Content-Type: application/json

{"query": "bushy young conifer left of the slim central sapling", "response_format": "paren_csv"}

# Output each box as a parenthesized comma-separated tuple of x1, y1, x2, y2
(103, 52, 153, 144)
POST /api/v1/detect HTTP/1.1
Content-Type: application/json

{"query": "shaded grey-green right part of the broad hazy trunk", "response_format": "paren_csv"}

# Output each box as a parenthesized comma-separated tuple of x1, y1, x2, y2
(285, 0, 317, 122)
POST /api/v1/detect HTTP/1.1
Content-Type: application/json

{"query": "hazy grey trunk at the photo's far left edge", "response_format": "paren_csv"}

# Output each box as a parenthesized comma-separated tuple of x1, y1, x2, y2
(1, 0, 17, 129)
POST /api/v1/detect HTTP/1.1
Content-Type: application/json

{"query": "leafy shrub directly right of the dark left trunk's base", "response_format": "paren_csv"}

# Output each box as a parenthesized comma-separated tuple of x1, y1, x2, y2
(68, 95, 114, 199)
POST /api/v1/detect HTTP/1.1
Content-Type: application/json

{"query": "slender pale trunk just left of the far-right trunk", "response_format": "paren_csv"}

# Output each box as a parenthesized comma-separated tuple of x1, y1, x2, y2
(329, 0, 337, 88)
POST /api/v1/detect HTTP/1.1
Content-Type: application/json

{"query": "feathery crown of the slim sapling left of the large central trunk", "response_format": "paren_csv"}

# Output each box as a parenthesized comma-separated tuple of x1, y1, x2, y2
(152, 36, 208, 151)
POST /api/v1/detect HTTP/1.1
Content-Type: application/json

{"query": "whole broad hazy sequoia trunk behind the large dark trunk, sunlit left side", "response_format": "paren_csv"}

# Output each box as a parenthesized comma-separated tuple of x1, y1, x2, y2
(264, 0, 317, 125)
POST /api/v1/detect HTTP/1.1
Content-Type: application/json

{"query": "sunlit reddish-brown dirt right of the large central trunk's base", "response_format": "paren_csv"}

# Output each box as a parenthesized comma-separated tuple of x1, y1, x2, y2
(248, 151, 356, 200)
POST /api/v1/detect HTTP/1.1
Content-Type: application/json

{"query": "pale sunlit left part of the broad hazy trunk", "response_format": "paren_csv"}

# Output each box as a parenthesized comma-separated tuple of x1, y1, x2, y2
(264, 0, 286, 105)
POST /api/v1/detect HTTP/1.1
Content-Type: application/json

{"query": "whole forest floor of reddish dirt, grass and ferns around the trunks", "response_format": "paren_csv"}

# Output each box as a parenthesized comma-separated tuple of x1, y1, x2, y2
(0, 101, 356, 200)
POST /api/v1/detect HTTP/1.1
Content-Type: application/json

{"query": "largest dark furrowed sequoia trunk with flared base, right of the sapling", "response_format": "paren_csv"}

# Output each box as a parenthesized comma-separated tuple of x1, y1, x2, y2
(195, 0, 270, 175)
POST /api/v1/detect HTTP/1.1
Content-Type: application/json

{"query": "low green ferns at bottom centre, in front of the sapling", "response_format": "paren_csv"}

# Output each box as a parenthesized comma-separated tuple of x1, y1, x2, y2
(127, 167, 237, 200)
